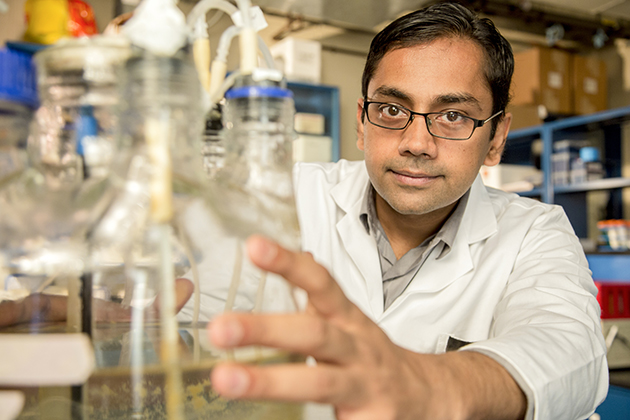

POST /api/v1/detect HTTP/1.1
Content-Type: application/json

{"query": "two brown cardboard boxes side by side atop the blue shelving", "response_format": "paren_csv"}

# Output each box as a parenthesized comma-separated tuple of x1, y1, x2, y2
(508, 47, 608, 129)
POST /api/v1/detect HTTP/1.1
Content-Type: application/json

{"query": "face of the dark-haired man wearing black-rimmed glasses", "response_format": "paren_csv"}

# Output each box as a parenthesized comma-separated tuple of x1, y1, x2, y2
(357, 38, 510, 215)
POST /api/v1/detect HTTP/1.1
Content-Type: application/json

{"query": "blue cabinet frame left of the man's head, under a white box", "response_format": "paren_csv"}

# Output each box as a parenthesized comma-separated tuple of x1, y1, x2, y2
(287, 82, 341, 162)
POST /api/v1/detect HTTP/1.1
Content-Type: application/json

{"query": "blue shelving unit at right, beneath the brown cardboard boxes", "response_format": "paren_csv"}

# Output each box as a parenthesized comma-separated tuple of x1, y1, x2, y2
(503, 107, 630, 237)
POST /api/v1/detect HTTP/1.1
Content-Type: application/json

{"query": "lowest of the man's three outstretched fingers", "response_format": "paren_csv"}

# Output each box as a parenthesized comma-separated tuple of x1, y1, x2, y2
(211, 363, 365, 408)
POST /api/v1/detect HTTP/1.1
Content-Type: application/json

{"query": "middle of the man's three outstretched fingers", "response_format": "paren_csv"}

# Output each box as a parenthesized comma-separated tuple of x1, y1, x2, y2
(208, 313, 357, 364)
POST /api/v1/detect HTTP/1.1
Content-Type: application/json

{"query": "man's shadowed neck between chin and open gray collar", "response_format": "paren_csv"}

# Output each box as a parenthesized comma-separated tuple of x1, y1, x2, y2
(374, 191, 458, 260)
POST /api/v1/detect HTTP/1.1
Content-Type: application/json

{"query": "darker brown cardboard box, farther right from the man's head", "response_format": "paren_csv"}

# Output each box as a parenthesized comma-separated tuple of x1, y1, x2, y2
(571, 55, 608, 114)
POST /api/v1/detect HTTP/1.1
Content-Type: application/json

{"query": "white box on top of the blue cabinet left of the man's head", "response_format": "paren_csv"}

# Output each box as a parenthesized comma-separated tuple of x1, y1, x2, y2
(269, 37, 322, 83)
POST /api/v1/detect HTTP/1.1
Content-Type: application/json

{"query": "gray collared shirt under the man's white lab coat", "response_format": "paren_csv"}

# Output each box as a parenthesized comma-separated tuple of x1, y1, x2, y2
(359, 185, 470, 310)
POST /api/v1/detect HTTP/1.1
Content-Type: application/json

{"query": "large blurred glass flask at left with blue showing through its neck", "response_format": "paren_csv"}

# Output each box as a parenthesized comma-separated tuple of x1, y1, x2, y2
(0, 37, 129, 332)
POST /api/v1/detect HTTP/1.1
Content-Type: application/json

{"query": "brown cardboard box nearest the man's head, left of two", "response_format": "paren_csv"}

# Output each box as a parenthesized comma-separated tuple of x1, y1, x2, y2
(512, 47, 573, 115)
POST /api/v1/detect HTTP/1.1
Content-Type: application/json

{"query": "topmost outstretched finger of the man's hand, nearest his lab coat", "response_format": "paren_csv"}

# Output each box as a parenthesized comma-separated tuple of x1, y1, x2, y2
(247, 235, 358, 317)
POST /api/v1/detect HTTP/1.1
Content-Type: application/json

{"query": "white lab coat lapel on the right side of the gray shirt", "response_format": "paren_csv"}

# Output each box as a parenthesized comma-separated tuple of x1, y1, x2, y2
(400, 177, 497, 296)
